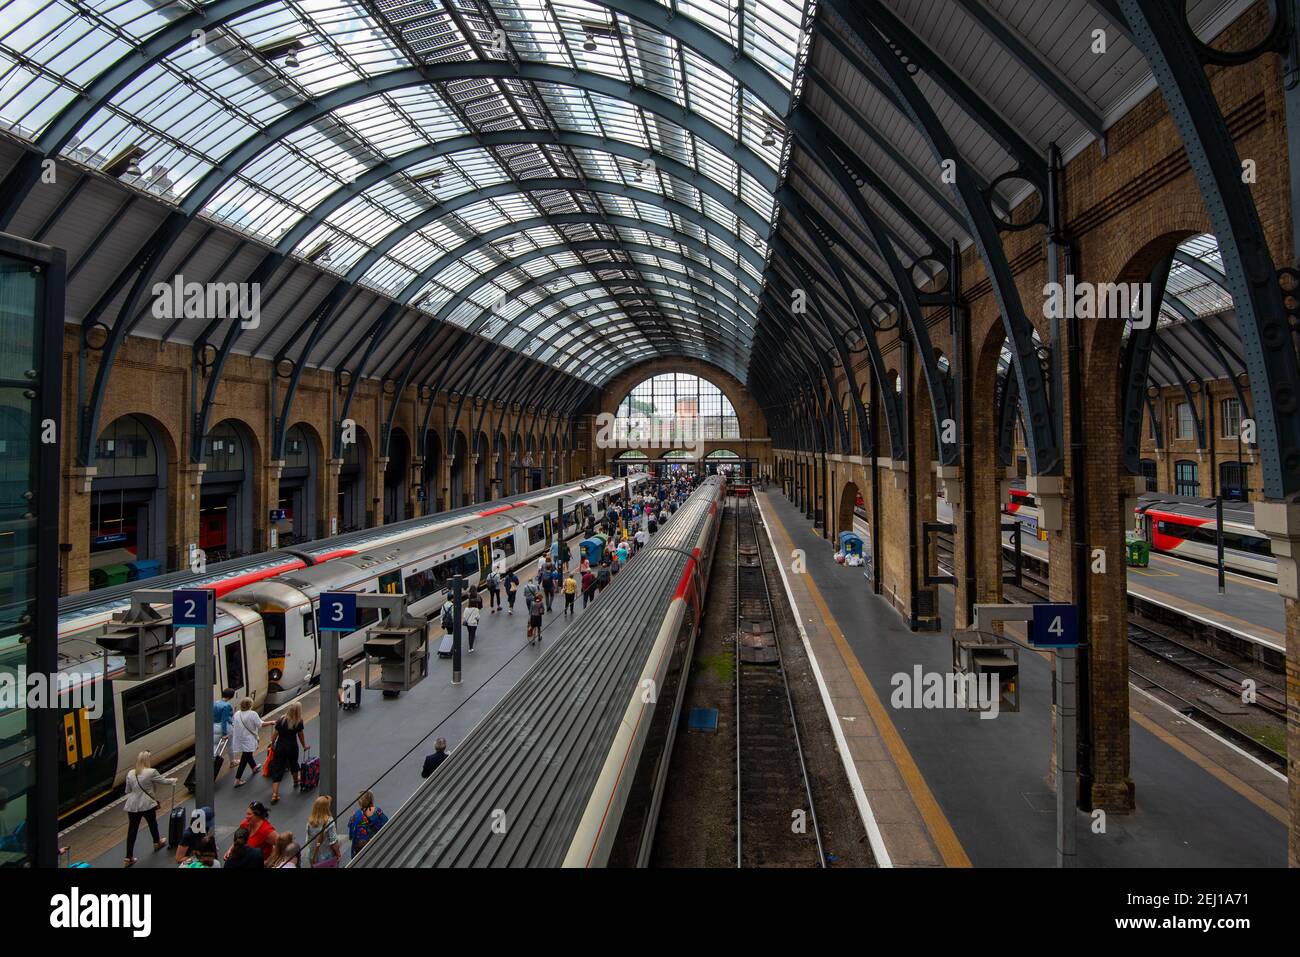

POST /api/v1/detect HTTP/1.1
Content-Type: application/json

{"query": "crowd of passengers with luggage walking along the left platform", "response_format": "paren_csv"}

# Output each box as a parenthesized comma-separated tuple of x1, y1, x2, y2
(124, 472, 697, 869)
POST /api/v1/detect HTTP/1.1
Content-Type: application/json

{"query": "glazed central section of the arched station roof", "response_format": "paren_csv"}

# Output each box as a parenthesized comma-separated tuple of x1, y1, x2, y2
(0, 0, 813, 382)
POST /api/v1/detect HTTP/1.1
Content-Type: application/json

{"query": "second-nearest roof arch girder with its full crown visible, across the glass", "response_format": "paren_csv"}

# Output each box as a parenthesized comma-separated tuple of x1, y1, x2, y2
(276, 130, 768, 255)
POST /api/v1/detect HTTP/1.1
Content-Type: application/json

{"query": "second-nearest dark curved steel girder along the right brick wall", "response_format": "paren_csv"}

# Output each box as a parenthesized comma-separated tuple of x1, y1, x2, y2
(828, 0, 1063, 475)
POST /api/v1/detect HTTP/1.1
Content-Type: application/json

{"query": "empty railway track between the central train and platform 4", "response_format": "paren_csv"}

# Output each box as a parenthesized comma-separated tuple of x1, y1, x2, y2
(732, 498, 826, 867)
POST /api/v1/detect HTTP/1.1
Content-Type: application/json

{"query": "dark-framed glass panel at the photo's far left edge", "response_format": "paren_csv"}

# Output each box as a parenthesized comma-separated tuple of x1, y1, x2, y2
(0, 235, 64, 867)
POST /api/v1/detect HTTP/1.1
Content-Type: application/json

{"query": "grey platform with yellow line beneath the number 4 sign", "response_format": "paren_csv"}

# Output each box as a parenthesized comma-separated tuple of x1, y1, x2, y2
(758, 493, 1287, 867)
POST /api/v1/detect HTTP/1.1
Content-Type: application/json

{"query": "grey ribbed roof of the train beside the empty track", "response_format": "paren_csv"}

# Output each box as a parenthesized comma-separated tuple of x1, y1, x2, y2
(354, 476, 720, 867)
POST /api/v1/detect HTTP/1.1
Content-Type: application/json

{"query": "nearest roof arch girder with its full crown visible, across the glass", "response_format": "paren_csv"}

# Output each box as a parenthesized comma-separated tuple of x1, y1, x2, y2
(181, 60, 780, 221)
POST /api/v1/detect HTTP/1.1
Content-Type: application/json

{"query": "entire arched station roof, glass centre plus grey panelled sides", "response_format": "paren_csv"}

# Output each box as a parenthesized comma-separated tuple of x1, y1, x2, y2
(0, 0, 1247, 400)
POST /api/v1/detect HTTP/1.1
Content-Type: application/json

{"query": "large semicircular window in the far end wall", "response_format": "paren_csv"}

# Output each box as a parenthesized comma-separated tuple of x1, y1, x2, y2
(614, 372, 741, 446)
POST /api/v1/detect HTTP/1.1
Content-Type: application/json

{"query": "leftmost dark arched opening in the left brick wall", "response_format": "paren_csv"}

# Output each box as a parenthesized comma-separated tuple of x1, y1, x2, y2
(90, 415, 168, 589)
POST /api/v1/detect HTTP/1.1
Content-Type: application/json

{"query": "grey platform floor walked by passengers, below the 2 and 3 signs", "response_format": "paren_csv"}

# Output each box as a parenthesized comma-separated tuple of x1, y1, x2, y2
(60, 538, 621, 869)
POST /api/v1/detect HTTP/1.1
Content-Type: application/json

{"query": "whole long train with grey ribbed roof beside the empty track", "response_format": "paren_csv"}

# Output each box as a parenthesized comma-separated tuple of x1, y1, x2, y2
(350, 475, 727, 867)
